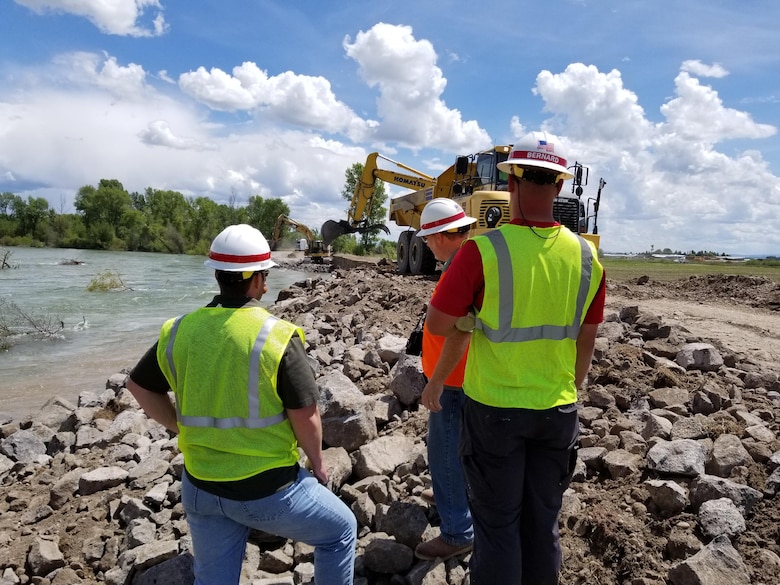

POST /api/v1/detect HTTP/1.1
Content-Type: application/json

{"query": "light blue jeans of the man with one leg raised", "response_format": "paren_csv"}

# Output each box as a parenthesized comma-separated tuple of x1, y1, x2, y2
(181, 469, 357, 585)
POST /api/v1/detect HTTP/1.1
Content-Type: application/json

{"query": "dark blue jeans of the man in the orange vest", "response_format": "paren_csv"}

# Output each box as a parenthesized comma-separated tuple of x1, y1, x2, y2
(428, 386, 474, 546)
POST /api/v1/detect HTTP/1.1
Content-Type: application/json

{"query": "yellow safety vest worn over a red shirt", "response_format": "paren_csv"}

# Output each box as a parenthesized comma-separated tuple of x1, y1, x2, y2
(463, 225, 604, 410)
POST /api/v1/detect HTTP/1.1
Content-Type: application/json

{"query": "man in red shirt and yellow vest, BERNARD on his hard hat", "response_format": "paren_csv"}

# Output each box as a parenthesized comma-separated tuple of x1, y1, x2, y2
(426, 132, 605, 585)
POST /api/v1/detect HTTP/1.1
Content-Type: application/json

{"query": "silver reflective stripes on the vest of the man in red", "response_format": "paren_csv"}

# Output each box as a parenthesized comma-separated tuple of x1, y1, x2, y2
(475, 230, 593, 343)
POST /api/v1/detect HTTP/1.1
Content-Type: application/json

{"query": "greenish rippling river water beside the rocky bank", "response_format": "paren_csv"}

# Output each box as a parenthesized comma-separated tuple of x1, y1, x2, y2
(0, 247, 327, 418)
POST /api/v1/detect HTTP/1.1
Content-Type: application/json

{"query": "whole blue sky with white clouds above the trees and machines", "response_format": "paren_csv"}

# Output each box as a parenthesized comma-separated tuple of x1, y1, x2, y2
(0, 0, 780, 255)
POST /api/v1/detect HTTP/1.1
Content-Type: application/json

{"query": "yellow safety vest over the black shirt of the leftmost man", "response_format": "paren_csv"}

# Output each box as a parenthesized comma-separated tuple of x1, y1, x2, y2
(157, 307, 304, 481)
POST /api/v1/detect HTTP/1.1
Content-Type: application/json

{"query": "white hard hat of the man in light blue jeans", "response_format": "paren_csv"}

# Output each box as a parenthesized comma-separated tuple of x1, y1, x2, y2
(204, 223, 276, 272)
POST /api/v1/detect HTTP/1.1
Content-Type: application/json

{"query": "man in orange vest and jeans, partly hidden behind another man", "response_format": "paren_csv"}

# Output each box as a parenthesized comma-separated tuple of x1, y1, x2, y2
(414, 198, 477, 561)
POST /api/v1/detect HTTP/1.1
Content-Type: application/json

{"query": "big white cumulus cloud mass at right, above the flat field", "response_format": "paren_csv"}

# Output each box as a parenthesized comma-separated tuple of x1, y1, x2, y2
(528, 61, 780, 251)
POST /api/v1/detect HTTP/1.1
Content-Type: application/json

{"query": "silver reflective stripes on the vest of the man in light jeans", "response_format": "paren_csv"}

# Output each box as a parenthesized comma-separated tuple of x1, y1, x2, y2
(165, 315, 287, 429)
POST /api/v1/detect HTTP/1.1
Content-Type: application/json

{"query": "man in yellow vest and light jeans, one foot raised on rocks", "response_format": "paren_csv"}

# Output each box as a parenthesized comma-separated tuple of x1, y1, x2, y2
(127, 224, 357, 585)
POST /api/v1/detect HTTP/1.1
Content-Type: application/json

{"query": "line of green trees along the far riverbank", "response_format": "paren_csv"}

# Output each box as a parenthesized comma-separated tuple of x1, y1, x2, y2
(0, 163, 387, 255)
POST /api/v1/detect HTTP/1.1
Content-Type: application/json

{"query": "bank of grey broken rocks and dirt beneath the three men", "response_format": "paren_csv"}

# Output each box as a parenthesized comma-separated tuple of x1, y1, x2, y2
(0, 267, 780, 585)
